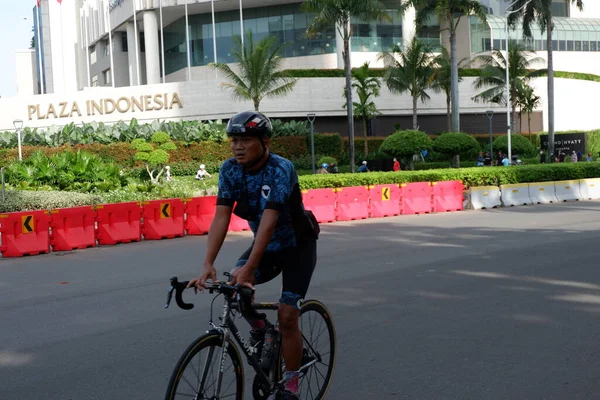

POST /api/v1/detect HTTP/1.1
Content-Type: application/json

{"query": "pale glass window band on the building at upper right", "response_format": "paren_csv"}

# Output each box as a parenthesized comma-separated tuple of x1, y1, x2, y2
(471, 15, 600, 53)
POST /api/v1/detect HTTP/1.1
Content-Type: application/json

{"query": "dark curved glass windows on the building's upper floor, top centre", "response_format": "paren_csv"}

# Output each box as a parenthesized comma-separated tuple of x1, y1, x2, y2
(164, 1, 406, 74)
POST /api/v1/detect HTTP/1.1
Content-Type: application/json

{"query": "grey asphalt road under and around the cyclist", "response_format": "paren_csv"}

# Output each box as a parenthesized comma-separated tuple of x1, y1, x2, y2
(0, 202, 600, 400)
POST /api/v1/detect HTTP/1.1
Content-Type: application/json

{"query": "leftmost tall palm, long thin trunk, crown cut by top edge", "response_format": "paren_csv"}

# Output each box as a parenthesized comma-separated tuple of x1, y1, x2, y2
(302, 0, 389, 172)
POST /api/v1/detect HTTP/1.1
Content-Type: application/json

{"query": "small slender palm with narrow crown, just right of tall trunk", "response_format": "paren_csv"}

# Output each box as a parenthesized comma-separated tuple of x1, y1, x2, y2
(343, 62, 381, 155)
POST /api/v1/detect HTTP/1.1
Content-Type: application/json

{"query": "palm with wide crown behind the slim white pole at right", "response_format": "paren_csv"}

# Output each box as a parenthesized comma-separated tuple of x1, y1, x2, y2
(473, 43, 546, 133)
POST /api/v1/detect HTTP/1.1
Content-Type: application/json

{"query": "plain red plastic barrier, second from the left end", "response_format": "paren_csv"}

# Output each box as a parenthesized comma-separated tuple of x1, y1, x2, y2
(50, 206, 96, 251)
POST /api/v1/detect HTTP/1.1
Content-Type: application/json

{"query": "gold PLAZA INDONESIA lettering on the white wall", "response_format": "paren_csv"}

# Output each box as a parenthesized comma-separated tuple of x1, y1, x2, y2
(27, 93, 183, 121)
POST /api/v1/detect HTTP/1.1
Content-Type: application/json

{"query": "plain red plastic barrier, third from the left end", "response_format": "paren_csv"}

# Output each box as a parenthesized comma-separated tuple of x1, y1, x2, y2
(96, 202, 142, 245)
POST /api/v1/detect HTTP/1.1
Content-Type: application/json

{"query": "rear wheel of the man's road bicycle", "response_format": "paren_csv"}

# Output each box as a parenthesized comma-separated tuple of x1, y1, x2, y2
(275, 300, 337, 400)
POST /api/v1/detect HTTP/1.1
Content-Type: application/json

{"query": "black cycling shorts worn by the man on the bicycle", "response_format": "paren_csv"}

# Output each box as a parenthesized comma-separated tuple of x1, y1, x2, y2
(235, 239, 317, 309)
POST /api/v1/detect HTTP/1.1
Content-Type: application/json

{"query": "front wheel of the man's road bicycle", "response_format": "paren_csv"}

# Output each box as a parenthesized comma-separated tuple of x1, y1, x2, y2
(165, 332, 244, 400)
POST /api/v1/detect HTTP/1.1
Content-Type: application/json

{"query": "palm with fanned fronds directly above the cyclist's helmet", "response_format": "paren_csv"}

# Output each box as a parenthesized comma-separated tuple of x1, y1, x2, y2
(209, 32, 297, 111)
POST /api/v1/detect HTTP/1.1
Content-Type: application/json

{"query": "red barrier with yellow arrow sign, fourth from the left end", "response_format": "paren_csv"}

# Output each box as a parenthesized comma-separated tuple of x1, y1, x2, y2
(142, 199, 185, 240)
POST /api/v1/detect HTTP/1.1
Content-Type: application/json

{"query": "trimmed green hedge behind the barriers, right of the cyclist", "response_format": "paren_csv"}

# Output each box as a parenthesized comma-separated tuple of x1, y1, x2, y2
(299, 162, 600, 189)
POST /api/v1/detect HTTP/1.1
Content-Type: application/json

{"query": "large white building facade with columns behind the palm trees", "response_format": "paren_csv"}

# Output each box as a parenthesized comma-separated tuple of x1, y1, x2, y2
(7, 0, 600, 134)
